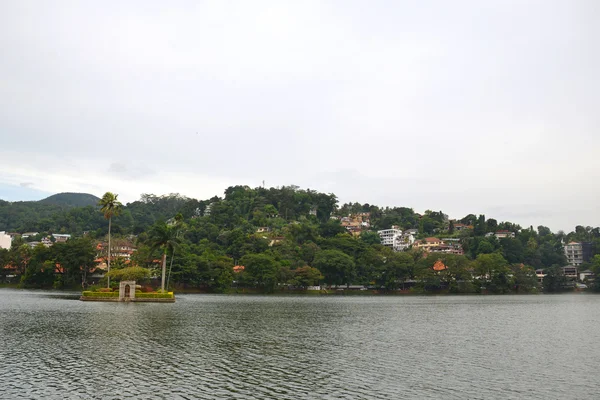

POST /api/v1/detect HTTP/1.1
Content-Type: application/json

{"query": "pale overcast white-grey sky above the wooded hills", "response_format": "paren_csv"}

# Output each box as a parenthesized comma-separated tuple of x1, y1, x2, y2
(0, 0, 600, 231)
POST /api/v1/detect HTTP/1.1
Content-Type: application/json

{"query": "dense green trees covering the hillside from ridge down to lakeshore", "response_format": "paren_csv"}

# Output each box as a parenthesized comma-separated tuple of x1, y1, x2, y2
(0, 186, 600, 293)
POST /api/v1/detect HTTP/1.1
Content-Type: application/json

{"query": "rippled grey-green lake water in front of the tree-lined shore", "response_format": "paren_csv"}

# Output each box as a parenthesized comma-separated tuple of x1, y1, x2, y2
(0, 289, 600, 399)
